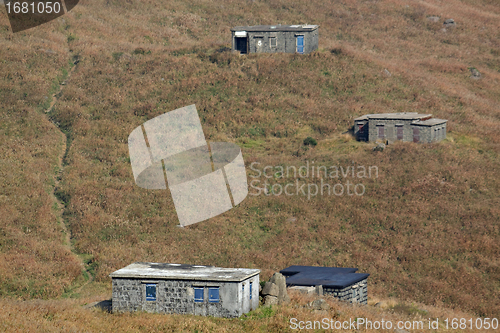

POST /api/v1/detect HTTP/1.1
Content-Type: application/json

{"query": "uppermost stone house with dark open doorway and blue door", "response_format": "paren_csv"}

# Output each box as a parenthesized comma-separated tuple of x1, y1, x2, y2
(231, 25, 319, 54)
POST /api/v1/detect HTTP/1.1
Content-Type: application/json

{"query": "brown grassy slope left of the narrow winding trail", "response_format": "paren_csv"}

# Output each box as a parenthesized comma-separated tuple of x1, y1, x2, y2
(0, 20, 81, 298)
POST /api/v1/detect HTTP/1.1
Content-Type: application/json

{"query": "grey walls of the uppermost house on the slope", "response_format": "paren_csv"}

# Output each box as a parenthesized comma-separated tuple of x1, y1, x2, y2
(232, 29, 319, 54)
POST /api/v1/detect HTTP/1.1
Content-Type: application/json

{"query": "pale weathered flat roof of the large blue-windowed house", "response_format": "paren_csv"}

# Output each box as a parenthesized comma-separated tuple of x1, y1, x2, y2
(109, 262, 260, 282)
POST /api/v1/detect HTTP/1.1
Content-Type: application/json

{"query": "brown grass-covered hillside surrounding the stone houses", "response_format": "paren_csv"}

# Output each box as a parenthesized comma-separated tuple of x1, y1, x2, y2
(0, 0, 500, 330)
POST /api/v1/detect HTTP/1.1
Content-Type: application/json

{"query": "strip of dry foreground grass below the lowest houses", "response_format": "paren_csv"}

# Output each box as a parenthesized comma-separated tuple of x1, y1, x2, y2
(0, 294, 484, 333)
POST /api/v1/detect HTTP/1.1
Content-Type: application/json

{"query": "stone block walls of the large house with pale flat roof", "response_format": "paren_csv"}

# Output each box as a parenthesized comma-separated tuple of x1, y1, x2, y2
(112, 275, 259, 317)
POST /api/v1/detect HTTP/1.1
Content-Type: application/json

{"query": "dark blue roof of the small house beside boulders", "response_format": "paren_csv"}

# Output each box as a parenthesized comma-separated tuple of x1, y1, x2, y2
(280, 266, 370, 288)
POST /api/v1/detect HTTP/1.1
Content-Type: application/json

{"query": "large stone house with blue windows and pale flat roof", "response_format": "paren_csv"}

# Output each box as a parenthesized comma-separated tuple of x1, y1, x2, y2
(110, 262, 260, 317)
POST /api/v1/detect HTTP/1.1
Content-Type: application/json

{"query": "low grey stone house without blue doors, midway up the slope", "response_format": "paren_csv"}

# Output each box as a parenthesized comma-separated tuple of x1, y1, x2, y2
(354, 112, 447, 143)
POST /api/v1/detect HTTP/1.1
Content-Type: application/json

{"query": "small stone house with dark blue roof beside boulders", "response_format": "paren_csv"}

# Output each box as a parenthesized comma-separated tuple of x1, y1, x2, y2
(280, 266, 370, 304)
